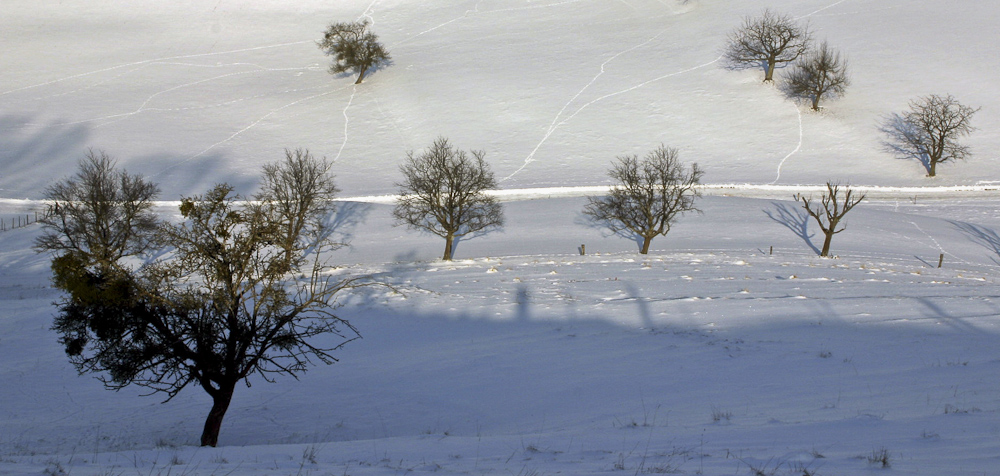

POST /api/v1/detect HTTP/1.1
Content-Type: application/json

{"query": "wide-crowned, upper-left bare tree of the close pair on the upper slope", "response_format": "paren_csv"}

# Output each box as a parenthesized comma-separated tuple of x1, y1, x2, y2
(725, 10, 812, 82)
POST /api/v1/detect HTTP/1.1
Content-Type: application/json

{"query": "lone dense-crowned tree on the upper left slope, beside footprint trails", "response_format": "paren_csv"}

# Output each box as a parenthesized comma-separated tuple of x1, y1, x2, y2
(317, 20, 392, 84)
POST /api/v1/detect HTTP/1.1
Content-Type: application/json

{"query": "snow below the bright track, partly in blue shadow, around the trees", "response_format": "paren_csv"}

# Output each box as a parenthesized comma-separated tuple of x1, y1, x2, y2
(0, 197, 1000, 475)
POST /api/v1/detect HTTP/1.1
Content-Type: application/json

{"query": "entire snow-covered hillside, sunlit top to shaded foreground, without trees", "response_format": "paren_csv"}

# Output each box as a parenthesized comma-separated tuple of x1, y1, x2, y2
(0, 0, 1000, 476)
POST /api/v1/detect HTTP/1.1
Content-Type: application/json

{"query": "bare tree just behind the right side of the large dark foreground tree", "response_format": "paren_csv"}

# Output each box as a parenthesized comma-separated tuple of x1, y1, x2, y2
(254, 149, 339, 266)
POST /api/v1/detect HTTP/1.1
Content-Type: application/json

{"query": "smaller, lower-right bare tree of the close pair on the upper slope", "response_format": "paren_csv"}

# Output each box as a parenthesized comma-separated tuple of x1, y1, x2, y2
(787, 41, 851, 111)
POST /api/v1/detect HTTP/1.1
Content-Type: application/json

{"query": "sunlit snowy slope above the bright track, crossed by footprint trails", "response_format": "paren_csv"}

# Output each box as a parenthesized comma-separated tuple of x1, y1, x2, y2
(0, 0, 1000, 199)
